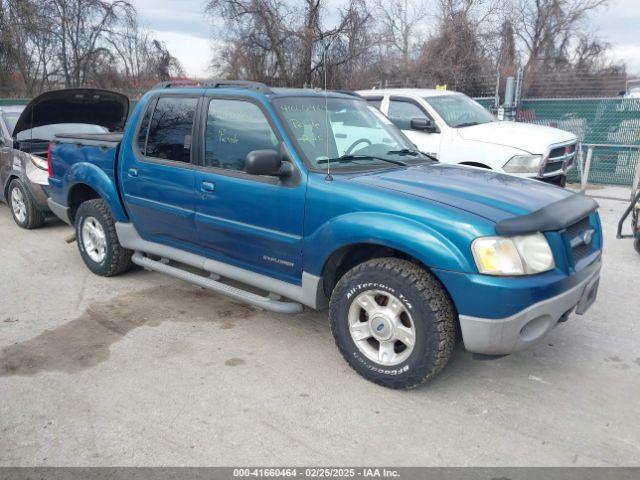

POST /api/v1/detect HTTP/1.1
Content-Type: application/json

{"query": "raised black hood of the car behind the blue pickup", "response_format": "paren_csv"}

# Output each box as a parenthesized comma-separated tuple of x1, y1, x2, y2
(12, 88, 129, 138)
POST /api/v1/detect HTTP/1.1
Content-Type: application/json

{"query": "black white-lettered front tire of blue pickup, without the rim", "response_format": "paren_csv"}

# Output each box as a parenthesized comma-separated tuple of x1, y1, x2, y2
(329, 258, 457, 389)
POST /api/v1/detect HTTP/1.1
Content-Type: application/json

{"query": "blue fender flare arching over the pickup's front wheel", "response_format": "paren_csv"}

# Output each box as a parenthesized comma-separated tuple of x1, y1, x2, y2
(304, 212, 473, 276)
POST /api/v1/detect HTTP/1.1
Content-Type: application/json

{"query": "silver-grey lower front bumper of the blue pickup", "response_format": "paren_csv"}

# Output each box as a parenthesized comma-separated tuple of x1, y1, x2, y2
(460, 266, 600, 355)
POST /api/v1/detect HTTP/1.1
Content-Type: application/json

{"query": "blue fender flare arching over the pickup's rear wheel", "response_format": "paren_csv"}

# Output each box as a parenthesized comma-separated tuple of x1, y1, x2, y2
(66, 162, 129, 222)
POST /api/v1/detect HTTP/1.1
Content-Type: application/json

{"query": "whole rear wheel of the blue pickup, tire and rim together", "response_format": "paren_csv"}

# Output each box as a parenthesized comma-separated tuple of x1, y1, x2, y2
(75, 199, 133, 277)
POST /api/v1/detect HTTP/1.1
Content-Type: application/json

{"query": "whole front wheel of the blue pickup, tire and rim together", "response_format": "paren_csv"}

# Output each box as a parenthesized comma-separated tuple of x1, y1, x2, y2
(329, 258, 457, 389)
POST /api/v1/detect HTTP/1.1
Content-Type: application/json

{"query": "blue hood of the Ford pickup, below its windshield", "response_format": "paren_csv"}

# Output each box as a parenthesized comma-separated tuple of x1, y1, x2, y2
(352, 163, 572, 222)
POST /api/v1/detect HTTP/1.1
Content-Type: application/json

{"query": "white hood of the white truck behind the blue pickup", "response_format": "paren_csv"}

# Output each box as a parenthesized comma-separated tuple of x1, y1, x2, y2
(458, 122, 577, 155)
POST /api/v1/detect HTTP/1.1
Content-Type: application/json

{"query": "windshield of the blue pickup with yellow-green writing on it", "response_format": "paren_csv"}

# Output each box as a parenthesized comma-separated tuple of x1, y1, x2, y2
(273, 97, 427, 170)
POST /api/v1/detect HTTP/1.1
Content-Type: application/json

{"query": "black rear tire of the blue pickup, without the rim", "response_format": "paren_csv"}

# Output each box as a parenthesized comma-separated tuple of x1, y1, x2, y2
(75, 199, 133, 277)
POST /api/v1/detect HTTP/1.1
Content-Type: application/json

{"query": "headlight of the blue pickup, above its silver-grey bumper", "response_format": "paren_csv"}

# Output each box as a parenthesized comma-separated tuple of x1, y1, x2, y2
(471, 233, 555, 275)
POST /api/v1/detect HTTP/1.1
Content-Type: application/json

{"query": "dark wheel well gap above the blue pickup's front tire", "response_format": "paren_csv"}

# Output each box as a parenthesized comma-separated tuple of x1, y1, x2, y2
(322, 243, 427, 298)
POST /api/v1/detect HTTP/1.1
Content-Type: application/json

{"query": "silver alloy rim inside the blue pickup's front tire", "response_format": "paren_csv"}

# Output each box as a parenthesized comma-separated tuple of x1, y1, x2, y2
(349, 290, 416, 366)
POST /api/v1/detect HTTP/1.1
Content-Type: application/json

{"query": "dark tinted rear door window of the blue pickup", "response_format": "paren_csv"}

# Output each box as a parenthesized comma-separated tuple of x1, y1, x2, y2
(145, 97, 198, 163)
